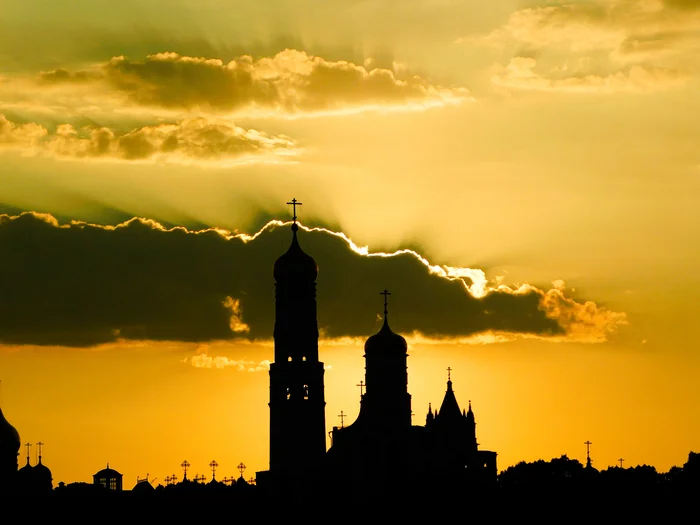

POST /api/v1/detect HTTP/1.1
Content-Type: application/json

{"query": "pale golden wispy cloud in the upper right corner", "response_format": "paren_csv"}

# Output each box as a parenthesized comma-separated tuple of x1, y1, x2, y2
(471, 0, 700, 93)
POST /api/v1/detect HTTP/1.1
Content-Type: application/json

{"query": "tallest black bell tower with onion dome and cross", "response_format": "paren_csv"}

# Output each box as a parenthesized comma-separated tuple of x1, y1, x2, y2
(270, 199, 326, 480)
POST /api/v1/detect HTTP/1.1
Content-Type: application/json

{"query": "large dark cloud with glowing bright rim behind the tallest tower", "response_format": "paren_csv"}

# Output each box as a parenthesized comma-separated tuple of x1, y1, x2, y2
(0, 212, 626, 348)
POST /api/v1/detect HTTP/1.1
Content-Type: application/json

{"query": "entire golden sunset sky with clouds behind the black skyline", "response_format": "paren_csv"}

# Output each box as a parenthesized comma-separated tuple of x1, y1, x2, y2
(0, 0, 700, 488)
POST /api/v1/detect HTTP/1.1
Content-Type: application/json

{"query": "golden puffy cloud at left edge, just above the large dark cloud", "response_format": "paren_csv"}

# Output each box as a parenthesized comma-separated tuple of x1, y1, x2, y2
(0, 113, 298, 166)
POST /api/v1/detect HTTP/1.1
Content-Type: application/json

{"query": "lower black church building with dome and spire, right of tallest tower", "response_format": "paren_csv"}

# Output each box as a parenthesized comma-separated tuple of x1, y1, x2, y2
(327, 290, 498, 490)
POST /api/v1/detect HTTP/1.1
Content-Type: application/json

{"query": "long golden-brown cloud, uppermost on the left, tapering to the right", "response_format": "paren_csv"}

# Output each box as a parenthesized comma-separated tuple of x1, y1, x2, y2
(32, 49, 468, 114)
